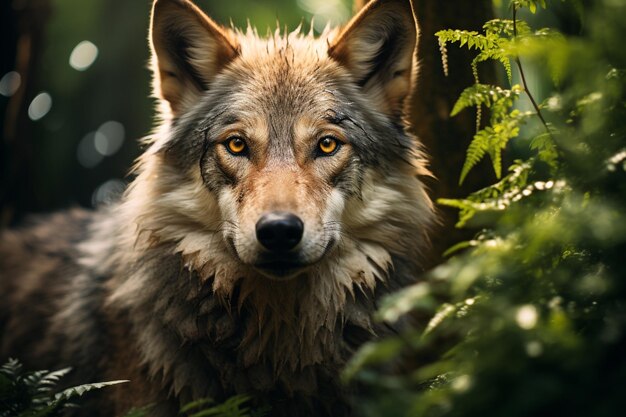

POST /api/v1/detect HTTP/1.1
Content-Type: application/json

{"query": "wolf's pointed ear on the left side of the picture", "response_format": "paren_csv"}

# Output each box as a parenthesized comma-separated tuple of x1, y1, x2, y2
(150, 0, 239, 116)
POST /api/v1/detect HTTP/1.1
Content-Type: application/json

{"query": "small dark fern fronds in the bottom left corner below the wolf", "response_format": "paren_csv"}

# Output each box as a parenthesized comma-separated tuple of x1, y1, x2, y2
(0, 359, 127, 417)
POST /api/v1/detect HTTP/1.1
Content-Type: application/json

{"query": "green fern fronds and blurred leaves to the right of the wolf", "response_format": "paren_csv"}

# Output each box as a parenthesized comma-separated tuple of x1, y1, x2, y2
(344, 0, 626, 417)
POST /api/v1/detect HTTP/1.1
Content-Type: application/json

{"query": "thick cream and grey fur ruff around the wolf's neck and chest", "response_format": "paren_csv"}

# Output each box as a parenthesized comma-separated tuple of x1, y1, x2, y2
(85, 128, 432, 397)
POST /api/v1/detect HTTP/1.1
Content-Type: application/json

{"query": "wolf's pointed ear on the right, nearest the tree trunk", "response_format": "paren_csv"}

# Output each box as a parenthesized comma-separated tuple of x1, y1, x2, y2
(328, 0, 418, 117)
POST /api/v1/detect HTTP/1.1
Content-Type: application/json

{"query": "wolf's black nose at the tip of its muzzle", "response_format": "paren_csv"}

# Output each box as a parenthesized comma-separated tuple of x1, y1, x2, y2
(256, 211, 304, 252)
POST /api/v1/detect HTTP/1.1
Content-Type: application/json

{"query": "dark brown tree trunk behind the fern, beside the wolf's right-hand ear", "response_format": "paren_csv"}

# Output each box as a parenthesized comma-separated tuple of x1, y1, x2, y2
(411, 0, 495, 268)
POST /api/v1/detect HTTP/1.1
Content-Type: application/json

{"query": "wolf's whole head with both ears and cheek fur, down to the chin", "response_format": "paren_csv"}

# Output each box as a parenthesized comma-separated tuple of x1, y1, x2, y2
(133, 0, 430, 279)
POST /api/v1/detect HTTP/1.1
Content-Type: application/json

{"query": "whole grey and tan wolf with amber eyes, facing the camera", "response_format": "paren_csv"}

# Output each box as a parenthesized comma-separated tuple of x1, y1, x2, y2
(0, 0, 436, 416)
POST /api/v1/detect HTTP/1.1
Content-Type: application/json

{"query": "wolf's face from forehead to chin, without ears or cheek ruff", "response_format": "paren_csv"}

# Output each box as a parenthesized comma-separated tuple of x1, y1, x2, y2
(195, 70, 352, 278)
